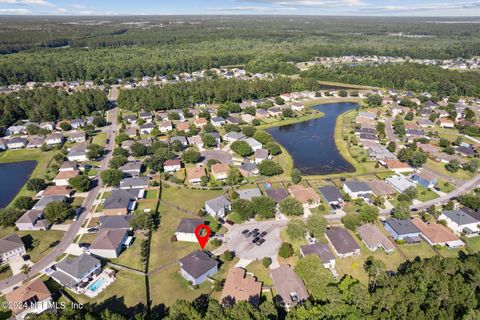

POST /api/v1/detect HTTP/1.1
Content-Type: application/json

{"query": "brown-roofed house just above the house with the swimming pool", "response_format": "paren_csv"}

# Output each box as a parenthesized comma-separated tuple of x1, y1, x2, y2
(89, 229, 128, 259)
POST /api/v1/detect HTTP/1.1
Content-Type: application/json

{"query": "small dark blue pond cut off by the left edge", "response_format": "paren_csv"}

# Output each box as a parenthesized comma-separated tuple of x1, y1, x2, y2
(0, 161, 37, 208)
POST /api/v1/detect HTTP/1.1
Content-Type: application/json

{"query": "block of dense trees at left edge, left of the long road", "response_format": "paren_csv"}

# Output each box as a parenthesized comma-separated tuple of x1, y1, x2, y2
(0, 88, 107, 127)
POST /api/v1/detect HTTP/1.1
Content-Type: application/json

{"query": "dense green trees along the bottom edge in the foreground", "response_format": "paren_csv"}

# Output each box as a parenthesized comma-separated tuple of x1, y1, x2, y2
(27, 253, 480, 320)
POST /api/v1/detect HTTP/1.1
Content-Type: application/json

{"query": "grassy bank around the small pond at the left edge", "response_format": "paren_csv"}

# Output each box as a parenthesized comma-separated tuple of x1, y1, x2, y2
(0, 149, 58, 206)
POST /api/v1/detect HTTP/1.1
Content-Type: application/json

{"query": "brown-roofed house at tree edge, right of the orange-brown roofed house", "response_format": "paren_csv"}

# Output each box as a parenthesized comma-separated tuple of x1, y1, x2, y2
(270, 265, 309, 309)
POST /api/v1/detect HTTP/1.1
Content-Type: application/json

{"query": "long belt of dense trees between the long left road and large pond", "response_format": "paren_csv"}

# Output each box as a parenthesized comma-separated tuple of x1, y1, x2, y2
(117, 77, 320, 111)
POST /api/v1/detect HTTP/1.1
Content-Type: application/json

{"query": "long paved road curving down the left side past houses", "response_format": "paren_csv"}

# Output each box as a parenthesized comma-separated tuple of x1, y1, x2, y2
(0, 99, 117, 292)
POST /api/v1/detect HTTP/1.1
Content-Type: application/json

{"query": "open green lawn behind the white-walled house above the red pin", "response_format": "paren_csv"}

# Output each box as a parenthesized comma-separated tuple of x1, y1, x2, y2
(161, 186, 223, 213)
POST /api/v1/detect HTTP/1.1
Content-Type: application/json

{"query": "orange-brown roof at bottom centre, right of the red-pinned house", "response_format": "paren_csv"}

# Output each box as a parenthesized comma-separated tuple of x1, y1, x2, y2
(220, 268, 262, 306)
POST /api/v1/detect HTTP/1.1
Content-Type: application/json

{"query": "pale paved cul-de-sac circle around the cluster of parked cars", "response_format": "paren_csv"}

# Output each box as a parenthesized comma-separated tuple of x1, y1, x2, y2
(225, 220, 288, 260)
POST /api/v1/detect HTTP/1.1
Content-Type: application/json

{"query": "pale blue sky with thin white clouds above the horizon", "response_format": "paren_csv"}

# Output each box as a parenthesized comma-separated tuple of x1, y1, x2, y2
(0, 0, 480, 17)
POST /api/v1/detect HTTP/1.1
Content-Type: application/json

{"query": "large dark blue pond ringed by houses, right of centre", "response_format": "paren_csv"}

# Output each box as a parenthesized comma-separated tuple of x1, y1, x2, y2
(267, 103, 358, 175)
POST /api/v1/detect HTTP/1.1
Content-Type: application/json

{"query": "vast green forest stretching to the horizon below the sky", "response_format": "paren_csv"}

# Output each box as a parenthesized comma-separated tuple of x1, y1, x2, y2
(0, 17, 480, 84)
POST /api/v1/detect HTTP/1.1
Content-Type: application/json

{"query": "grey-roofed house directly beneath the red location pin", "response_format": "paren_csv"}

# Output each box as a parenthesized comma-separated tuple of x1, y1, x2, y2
(180, 250, 218, 285)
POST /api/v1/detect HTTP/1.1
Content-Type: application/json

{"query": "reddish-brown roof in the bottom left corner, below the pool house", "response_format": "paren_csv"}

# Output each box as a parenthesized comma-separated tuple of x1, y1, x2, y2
(5, 279, 51, 314)
